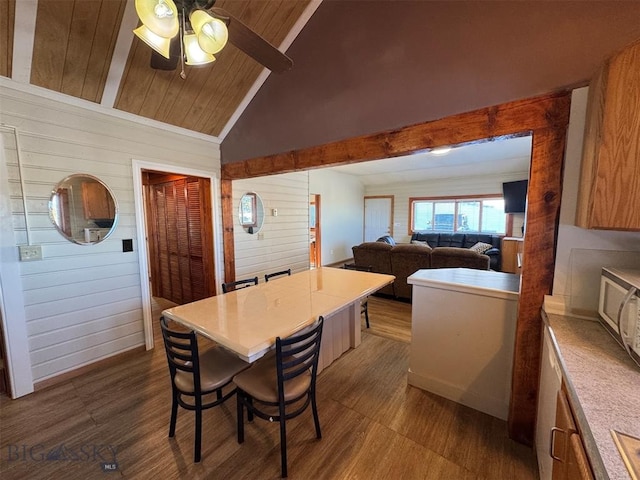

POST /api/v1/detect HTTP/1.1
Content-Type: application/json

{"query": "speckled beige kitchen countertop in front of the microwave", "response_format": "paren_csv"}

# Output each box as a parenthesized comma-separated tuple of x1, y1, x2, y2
(543, 310, 640, 480)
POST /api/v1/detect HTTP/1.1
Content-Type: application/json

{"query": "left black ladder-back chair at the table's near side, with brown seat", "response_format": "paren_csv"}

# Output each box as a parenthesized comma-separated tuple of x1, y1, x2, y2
(160, 317, 250, 463)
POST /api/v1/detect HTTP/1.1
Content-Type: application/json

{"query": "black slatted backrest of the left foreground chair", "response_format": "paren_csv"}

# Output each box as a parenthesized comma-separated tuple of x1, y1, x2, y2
(160, 316, 200, 395)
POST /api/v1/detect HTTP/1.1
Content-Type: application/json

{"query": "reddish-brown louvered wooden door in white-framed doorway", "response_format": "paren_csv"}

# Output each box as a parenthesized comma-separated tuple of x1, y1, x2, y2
(145, 173, 215, 304)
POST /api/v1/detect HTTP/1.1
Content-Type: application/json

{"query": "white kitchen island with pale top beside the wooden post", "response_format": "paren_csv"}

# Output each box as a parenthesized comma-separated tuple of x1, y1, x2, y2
(407, 268, 520, 420)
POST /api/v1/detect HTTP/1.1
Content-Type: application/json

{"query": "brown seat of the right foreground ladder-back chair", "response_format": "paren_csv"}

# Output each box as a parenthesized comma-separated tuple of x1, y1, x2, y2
(233, 357, 311, 403)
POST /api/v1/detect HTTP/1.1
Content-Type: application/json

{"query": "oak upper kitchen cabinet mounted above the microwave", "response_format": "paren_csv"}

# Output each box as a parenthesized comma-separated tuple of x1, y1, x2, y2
(576, 42, 640, 230)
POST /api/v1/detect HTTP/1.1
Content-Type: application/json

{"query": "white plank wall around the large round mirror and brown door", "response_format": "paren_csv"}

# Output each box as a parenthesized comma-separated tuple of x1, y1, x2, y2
(0, 79, 220, 394)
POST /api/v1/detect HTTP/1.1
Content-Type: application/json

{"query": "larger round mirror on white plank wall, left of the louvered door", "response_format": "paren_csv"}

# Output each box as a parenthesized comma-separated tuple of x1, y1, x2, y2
(49, 173, 119, 245)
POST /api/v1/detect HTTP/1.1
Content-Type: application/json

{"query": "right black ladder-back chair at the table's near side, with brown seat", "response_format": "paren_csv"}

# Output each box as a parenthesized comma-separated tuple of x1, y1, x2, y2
(233, 317, 324, 478)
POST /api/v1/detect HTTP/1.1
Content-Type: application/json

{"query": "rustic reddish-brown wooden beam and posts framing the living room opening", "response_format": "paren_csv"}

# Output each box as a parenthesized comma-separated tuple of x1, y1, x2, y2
(222, 91, 571, 445)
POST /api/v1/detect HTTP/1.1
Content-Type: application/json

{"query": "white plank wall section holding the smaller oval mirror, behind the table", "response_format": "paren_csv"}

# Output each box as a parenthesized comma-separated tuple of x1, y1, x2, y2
(232, 172, 309, 281)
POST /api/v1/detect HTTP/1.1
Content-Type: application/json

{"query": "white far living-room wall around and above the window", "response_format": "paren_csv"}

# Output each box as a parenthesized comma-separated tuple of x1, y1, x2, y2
(365, 171, 529, 243)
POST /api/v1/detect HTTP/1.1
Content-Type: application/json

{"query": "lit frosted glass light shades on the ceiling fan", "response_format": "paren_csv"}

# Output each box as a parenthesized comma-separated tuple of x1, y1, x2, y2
(133, 0, 229, 73)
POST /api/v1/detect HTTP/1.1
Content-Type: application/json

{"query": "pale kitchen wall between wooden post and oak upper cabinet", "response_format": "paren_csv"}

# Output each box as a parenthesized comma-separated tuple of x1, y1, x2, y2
(553, 87, 640, 316)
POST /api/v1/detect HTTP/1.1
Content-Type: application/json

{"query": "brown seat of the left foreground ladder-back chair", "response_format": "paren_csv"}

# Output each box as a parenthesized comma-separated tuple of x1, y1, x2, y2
(175, 347, 250, 392)
